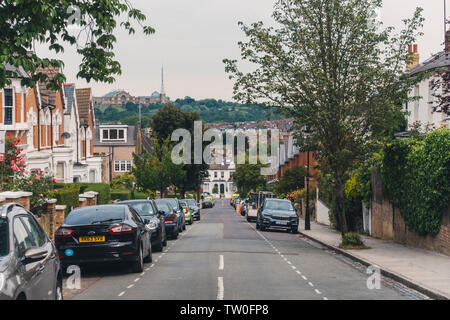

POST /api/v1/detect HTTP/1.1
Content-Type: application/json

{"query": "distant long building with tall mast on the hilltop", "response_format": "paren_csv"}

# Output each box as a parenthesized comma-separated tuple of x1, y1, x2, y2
(94, 69, 170, 106)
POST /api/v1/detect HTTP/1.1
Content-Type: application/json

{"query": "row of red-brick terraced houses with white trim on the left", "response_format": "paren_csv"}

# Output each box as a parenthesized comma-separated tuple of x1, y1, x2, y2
(0, 65, 101, 183)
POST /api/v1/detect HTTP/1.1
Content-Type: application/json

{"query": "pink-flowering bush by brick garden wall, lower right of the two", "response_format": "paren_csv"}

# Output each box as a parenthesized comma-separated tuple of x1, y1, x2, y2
(12, 169, 58, 214)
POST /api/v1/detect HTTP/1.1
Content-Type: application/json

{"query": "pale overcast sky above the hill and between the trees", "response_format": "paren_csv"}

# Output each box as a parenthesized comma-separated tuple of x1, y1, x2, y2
(36, 0, 444, 101)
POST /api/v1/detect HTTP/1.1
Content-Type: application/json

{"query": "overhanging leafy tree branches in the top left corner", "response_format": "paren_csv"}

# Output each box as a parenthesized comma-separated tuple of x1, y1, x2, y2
(0, 0, 154, 90)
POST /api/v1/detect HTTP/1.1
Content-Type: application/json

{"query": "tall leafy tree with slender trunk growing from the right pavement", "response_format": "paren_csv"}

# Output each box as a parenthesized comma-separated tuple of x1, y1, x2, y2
(224, 0, 423, 234)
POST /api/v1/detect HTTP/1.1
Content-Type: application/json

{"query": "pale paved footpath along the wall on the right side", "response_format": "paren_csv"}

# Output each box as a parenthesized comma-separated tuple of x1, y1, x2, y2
(299, 220, 450, 299)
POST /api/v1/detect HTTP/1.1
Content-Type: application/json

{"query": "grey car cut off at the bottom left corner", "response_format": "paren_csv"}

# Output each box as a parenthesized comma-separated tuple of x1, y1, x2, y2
(0, 203, 63, 300)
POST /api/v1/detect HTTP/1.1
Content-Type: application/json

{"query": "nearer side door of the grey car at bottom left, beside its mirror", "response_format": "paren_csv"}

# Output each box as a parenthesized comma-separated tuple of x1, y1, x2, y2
(12, 216, 41, 300)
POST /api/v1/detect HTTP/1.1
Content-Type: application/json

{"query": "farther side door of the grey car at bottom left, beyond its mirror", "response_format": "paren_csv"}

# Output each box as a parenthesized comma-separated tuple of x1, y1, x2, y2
(20, 214, 59, 299)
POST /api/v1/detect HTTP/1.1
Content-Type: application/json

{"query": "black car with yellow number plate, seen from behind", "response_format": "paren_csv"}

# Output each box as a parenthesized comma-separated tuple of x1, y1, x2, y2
(55, 204, 152, 272)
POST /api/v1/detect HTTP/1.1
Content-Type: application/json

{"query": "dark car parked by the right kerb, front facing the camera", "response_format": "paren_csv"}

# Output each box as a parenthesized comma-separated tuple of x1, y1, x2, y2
(256, 199, 298, 233)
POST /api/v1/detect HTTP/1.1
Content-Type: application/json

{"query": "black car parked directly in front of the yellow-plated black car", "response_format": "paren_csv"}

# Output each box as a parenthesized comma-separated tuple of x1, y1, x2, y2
(117, 200, 167, 252)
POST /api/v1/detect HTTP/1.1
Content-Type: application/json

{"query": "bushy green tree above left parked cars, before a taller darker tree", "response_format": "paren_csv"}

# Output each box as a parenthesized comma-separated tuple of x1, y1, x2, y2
(132, 138, 185, 196)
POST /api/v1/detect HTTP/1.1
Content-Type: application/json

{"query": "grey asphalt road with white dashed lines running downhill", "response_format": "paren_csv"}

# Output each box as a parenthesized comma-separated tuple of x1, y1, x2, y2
(64, 200, 426, 300)
